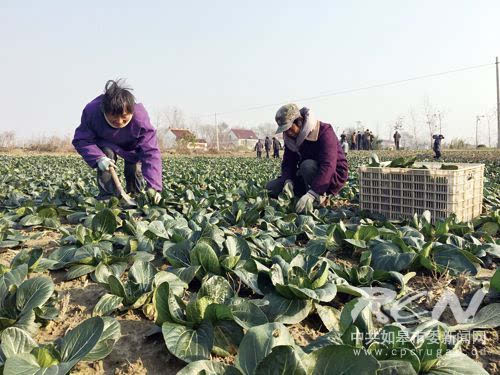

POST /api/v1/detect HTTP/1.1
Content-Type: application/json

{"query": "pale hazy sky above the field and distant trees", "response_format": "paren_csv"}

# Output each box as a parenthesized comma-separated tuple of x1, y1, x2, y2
(0, 0, 500, 143)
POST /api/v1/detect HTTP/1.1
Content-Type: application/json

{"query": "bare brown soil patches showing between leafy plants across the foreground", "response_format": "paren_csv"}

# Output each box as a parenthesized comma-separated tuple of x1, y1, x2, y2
(0, 223, 500, 375)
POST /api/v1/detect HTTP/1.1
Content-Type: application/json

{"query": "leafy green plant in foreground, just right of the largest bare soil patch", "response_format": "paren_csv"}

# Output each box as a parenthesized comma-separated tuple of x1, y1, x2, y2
(153, 276, 267, 362)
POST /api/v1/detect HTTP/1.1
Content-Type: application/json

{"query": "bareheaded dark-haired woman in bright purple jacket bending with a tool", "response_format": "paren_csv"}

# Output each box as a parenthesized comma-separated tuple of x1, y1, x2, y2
(73, 80, 162, 200)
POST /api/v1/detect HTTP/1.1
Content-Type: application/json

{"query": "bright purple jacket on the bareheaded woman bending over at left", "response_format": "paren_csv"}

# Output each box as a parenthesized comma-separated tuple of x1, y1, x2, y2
(73, 95, 162, 191)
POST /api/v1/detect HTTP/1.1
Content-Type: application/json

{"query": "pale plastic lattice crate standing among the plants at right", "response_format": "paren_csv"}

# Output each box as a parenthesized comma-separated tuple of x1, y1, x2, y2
(359, 162, 484, 222)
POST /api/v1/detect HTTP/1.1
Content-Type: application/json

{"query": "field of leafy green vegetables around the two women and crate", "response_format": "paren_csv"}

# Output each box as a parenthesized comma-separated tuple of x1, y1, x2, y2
(0, 151, 500, 375)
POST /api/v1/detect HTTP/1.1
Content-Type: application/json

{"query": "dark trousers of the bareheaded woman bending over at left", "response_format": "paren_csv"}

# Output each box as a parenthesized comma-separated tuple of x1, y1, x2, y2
(97, 147, 146, 200)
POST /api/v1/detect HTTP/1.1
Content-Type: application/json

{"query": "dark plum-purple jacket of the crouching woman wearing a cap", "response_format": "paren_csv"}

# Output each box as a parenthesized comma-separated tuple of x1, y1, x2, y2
(281, 122, 348, 195)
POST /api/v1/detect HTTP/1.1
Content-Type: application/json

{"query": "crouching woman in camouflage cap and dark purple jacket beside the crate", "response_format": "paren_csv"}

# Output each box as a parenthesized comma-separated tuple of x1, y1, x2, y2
(267, 104, 348, 213)
